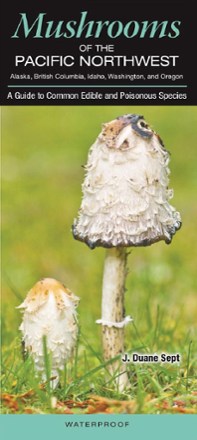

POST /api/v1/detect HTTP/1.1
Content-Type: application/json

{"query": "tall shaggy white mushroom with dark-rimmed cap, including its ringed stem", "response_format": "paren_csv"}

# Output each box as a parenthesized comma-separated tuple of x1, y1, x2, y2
(73, 114, 181, 390)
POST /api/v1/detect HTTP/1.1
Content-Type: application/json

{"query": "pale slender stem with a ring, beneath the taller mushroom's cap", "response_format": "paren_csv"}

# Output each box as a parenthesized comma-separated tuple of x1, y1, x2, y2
(101, 247, 129, 391)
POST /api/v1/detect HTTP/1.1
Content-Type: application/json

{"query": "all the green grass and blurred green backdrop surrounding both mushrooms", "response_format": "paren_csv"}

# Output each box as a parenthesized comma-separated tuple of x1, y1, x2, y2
(1, 106, 197, 414)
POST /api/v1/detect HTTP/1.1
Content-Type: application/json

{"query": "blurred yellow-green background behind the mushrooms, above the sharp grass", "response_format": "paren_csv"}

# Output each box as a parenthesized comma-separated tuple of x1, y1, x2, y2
(2, 106, 197, 355)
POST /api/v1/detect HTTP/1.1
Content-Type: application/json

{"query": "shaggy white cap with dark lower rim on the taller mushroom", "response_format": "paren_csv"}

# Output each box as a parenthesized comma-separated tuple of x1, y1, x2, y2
(73, 114, 181, 249)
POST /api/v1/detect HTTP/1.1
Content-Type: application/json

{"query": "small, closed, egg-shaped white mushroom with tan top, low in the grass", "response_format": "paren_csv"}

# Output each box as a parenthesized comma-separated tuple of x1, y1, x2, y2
(17, 278, 79, 388)
